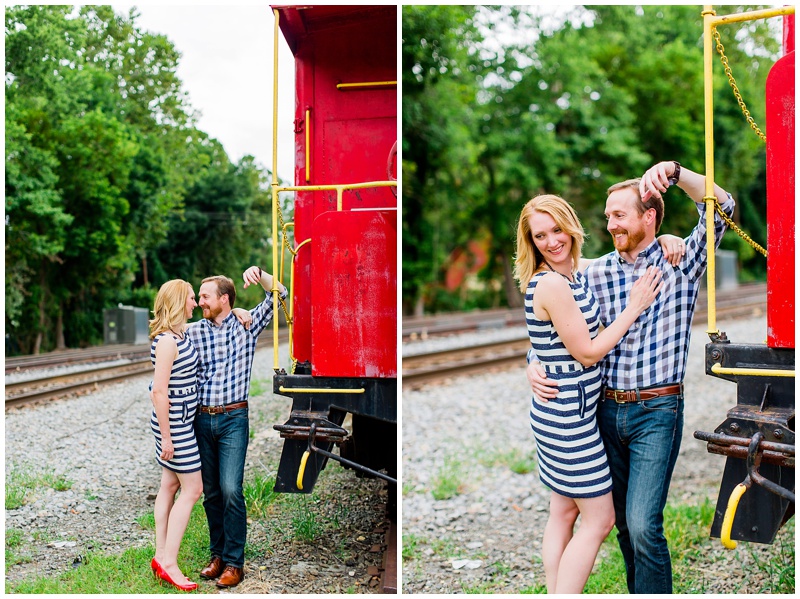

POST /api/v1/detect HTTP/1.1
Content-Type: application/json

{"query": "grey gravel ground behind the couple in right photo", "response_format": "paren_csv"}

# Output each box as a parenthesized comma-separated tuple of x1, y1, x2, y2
(402, 317, 796, 593)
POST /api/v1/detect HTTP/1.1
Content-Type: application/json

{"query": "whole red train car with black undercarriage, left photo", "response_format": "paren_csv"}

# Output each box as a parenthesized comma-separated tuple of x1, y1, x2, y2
(273, 5, 398, 501)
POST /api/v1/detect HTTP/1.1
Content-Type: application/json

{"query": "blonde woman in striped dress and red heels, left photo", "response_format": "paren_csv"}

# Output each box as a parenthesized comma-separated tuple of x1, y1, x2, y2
(150, 279, 251, 591)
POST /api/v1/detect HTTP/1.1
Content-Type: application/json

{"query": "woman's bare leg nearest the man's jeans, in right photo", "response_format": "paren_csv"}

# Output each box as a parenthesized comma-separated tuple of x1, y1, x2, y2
(548, 492, 614, 594)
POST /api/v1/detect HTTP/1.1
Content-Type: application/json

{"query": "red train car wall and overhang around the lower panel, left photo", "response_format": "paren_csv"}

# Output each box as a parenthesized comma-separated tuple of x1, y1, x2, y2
(275, 5, 397, 376)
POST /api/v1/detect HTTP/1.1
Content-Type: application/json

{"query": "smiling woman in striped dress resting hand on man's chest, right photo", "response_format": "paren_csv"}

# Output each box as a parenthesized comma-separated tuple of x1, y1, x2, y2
(515, 195, 663, 593)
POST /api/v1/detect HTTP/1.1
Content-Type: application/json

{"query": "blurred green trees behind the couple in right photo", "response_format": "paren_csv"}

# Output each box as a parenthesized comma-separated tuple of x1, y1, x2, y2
(403, 5, 778, 314)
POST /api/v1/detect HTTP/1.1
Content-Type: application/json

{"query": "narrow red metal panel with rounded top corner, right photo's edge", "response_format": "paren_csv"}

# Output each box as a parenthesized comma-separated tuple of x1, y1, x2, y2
(766, 52, 795, 348)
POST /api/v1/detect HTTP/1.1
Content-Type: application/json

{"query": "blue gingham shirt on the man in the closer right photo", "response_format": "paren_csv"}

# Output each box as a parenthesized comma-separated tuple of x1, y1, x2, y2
(586, 194, 735, 391)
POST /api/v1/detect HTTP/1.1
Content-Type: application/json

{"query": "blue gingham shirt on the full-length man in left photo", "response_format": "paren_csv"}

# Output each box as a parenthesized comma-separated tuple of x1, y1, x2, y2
(186, 291, 287, 406)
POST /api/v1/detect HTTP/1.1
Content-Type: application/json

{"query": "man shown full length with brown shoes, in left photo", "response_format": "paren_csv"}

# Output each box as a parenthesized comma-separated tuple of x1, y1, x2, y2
(187, 266, 286, 588)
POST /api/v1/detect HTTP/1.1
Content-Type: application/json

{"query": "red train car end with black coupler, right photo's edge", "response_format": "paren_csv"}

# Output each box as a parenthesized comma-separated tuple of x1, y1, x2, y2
(695, 9, 796, 548)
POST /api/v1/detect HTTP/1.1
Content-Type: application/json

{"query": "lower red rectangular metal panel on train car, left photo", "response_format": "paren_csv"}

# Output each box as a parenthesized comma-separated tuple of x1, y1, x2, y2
(311, 210, 397, 378)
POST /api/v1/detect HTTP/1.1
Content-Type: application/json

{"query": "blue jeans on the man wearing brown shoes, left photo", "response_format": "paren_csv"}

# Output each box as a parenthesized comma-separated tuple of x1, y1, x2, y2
(194, 408, 250, 568)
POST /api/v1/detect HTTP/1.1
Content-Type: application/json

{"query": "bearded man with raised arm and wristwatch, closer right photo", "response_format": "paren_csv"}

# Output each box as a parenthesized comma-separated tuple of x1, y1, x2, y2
(527, 162, 734, 593)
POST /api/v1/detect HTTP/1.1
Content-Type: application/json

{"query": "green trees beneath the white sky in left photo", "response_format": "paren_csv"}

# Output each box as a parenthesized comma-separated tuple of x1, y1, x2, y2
(5, 5, 282, 355)
